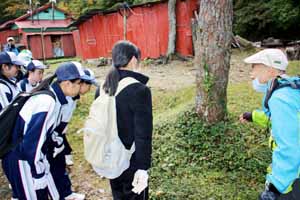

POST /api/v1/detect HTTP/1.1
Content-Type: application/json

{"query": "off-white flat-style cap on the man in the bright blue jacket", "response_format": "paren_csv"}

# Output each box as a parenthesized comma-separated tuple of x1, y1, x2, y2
(244, 49, 289, 71)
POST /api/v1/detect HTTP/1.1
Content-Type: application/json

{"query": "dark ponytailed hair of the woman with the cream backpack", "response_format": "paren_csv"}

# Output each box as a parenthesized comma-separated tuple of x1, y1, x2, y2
(103, 40, 141, 96)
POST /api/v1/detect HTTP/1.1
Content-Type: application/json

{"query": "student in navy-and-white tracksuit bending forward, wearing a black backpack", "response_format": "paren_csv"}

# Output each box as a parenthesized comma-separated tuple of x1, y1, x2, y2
(2, 63, 84, 200)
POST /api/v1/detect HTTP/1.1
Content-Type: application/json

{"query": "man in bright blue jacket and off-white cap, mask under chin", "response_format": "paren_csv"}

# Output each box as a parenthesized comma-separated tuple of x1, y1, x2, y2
(240, 49, 300, 200)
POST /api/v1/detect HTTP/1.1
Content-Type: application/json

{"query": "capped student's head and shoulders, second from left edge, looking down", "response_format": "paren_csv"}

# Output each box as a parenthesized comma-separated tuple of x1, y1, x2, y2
(17, 60, 47, 92)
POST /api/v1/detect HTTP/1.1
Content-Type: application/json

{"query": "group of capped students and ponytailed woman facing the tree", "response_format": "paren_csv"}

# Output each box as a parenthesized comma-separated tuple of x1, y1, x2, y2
(0, 41, 152, 200)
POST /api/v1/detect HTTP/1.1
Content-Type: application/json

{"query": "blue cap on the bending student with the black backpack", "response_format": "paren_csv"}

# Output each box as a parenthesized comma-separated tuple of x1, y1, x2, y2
(55, 62, 84, 81)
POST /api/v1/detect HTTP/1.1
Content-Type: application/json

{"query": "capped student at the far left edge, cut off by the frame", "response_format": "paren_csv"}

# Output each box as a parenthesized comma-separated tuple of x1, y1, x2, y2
(0, 52, 25, 111)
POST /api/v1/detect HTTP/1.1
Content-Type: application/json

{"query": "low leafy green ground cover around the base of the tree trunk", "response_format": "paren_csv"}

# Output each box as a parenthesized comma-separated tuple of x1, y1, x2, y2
(151, 109, 271, 199)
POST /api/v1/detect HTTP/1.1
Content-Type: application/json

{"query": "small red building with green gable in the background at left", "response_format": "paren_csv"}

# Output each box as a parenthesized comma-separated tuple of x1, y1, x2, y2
(0, 3, 76, 59)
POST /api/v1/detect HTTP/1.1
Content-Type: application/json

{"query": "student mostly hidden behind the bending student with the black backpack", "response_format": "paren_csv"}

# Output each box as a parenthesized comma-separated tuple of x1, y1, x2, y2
(49, 67, 97, 200)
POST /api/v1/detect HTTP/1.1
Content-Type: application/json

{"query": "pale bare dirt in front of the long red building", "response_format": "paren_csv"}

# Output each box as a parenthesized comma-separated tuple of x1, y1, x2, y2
(92, 51, 251, 91)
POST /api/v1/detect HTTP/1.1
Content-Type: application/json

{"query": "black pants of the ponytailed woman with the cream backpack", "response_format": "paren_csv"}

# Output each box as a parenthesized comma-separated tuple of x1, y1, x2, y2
(110, 168, 149, 200)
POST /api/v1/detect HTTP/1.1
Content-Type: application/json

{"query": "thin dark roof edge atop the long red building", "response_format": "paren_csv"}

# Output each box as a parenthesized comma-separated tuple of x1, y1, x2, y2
(70, 0, 164, 26)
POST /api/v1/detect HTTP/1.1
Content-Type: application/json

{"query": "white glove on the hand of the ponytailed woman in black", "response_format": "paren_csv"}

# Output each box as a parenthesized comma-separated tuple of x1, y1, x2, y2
(132, 169, 149, 194)
